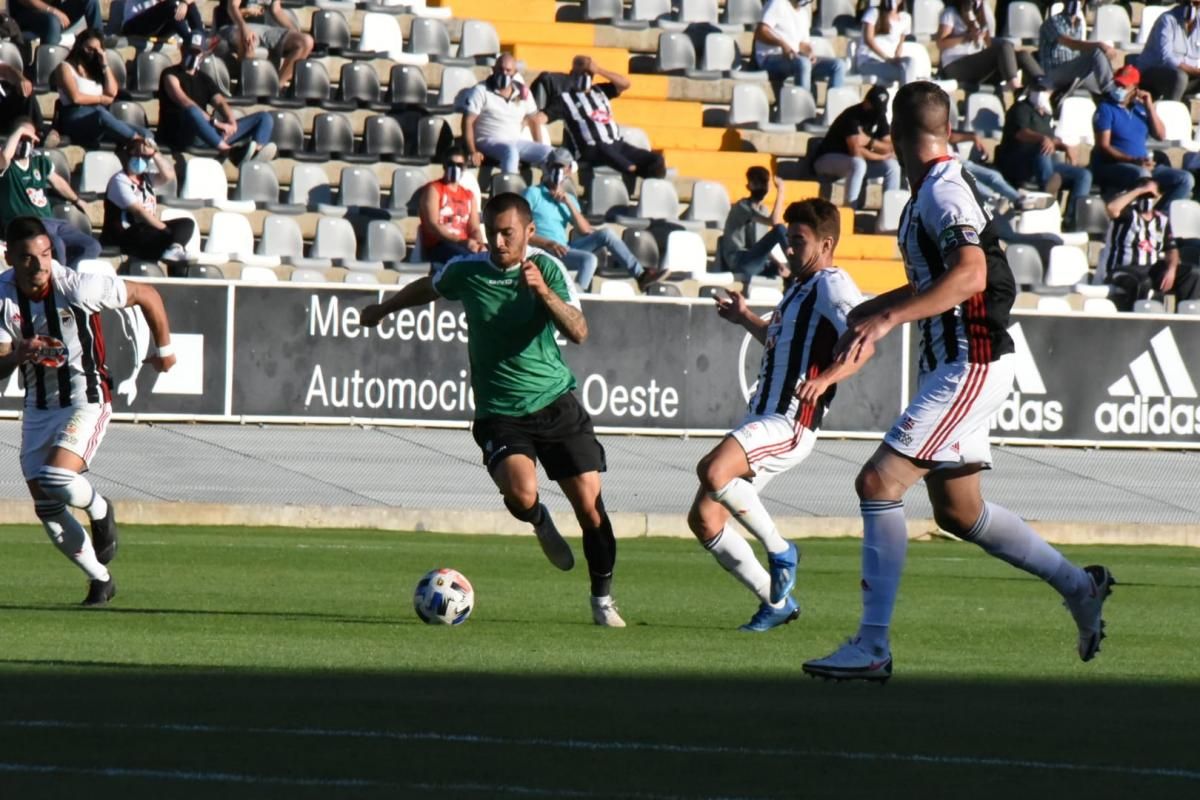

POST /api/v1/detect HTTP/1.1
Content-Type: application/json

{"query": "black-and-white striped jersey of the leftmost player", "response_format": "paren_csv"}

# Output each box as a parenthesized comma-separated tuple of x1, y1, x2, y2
(0, 261, 127, 409)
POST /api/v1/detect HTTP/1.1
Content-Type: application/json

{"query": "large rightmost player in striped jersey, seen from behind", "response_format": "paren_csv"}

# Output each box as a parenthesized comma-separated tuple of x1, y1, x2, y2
(800, 82, 1115, 680)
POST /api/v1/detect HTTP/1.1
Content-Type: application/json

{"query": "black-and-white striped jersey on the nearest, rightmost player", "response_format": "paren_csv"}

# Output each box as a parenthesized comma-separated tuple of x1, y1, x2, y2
(900, 156, 1016, 372)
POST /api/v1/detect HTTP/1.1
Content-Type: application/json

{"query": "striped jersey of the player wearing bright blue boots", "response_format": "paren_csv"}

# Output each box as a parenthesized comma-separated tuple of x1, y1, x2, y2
(749, 269, 863, 431)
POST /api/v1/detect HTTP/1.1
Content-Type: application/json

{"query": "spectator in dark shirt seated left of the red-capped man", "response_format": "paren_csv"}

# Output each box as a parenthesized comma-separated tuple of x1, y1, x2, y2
(996, 77, 1092, 229)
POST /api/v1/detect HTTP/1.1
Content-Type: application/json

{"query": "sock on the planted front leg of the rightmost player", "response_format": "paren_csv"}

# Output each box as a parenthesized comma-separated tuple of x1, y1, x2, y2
(858, 500, 908, 648)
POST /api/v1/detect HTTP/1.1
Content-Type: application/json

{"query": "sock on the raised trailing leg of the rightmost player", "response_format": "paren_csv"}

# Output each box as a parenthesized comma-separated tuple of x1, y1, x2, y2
(962, 503, 1091, 597)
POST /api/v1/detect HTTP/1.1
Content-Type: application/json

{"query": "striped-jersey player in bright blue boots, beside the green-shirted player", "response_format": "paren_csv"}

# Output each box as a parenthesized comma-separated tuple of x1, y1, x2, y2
(688, 199, 863, 633)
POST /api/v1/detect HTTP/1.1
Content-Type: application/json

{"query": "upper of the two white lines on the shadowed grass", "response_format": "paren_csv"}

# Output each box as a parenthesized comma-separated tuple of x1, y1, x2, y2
(0, 720, 1200, 781)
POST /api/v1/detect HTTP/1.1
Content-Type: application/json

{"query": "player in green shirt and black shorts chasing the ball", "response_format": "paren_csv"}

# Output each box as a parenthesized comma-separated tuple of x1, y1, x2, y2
(361, 193, 625, 627)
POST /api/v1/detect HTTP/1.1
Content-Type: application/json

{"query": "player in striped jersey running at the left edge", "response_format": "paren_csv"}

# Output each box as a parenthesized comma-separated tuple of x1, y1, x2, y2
(0, 217, 175, 607)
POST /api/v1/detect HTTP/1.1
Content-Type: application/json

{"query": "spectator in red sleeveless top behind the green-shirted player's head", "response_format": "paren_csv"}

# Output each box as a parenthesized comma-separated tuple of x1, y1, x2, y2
(416, 149, 487, 264)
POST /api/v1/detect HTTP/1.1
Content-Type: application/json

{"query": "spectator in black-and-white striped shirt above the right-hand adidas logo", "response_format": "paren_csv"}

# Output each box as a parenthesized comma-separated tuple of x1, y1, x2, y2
(1098, 178, 1200, 311)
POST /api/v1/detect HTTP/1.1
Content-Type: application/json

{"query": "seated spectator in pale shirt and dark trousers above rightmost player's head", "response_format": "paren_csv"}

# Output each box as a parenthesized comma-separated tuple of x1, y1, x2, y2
(936, 0, 1042, 90)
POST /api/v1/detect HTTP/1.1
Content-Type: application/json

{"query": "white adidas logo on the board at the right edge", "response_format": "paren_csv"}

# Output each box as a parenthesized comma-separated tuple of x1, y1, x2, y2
(1096, 327, 1200, 435)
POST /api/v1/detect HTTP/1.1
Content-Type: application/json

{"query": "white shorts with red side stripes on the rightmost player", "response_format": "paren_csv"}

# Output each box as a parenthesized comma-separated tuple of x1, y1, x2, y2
(883, 354, 1015, 468)
